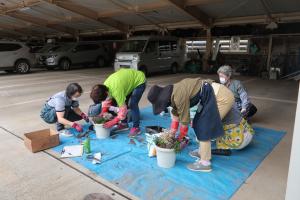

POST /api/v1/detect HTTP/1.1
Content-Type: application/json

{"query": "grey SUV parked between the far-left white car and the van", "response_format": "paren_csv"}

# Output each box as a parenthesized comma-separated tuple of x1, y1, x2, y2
(40, 42, 107, 70)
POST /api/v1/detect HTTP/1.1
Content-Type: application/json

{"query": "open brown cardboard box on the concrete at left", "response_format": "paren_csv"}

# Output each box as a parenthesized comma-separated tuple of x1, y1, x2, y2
(24, 129, 59, 153)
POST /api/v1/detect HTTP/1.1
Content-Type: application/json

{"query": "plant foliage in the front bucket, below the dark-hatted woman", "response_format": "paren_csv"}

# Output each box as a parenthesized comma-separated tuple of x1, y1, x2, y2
(154, 132, 181, 153)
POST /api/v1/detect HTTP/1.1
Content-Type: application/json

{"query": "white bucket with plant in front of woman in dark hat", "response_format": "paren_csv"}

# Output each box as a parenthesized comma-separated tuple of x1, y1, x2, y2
(154, 130, 181, 168)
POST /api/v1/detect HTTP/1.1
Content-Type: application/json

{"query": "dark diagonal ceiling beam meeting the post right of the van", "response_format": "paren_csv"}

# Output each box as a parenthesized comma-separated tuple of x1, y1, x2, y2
(168, 0, 212, 28)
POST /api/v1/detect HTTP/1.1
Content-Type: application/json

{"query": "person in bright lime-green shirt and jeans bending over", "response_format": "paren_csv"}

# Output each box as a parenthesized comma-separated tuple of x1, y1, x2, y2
(90, 69, 146, 137)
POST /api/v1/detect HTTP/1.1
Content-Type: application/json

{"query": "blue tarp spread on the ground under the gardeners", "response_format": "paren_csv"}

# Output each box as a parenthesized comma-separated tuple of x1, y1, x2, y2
(54, 108, 285, 200)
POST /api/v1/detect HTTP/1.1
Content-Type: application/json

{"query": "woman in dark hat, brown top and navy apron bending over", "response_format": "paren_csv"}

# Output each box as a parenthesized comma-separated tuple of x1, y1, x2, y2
(148, 78, 234, 172)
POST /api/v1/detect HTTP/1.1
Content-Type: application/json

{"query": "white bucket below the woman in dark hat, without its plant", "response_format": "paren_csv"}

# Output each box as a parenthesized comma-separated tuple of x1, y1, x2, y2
(155, 146, 176, 168)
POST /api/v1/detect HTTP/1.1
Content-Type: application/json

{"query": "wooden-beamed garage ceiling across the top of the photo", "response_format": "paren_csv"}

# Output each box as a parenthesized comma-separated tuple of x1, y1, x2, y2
(0, 0, 300, 37)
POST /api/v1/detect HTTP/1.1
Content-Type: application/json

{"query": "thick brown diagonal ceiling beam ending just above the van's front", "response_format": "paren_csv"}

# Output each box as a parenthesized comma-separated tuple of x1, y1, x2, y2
(48, 0, 129, 33)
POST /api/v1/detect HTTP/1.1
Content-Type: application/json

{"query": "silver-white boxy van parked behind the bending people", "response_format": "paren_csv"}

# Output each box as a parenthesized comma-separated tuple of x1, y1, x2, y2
(114, 36, 186, 74)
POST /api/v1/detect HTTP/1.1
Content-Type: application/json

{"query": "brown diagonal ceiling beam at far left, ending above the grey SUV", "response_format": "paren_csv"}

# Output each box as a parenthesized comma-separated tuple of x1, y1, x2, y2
(6, 11, 78, 36)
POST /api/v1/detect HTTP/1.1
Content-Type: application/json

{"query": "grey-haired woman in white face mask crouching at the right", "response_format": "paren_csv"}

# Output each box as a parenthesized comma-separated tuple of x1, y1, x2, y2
(218, 65, 257, 119)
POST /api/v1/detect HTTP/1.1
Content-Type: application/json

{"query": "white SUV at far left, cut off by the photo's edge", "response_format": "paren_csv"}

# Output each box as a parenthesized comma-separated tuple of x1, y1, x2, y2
(0, 41, 36, 74)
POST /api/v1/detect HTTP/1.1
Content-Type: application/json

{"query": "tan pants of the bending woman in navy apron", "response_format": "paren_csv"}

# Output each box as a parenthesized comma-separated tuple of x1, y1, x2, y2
(199, 83, 234, 161)
